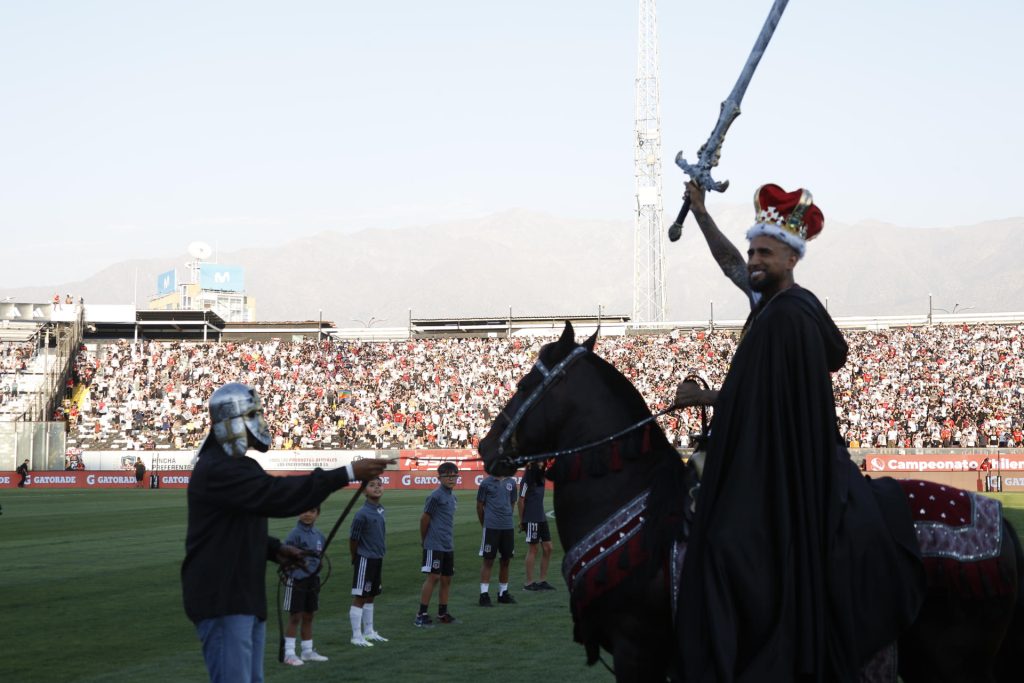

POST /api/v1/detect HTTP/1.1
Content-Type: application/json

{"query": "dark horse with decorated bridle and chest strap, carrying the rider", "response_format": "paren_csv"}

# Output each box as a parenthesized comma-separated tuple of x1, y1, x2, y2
(479, 325, 1024, 683)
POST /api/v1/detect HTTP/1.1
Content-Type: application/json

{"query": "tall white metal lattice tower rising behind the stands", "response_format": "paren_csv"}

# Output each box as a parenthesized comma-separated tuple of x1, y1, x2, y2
(633, 0, 666, 323)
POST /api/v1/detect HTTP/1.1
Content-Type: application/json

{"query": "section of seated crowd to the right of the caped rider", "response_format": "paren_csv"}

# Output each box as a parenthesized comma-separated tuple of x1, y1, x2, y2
(834, 325, 1024, 449)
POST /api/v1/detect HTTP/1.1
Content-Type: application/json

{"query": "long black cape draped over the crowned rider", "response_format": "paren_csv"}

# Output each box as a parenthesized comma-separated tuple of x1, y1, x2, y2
(678, 287, 925, 683)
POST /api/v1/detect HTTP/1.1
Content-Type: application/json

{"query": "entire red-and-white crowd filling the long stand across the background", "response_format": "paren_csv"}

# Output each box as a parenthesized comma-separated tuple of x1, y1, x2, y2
(68, 325, 1024, 449)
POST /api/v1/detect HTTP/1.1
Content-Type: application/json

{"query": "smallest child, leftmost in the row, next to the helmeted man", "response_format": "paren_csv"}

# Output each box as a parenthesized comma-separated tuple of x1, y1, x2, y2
(284, 506, 327, 667)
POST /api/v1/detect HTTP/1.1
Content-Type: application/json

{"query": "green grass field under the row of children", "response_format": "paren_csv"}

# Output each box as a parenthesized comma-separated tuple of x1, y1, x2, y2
(6, 489, 1024, 683)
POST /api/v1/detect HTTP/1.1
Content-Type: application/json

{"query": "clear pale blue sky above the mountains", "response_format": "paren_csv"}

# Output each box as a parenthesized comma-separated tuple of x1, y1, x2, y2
(0, 0, 1024, 287)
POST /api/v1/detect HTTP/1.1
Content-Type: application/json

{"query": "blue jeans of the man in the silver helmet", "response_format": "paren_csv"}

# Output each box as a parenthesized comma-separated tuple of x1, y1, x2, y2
(196, 614, 266, 683)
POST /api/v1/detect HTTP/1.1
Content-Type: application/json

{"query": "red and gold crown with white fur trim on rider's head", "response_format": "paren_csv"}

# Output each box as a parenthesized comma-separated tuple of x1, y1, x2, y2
(746, 183, 825, 258)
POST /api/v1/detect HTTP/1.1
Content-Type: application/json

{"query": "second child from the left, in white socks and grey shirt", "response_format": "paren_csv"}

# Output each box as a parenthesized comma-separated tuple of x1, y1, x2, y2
(348, 478, 387, 647)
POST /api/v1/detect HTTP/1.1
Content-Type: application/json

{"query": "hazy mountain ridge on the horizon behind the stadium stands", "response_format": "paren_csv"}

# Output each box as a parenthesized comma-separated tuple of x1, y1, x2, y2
(0, 207, 1024, 327)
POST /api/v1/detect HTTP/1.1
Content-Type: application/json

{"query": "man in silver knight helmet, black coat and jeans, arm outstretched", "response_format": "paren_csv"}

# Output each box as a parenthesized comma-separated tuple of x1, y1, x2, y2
(181, 383, 390, 682)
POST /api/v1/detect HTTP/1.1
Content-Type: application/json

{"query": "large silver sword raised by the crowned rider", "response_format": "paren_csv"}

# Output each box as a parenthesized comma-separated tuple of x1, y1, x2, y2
(669, 0, 790, 242)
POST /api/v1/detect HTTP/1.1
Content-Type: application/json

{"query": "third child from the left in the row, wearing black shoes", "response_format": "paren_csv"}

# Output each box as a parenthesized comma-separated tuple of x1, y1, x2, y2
(414, 463, 459, 628)
